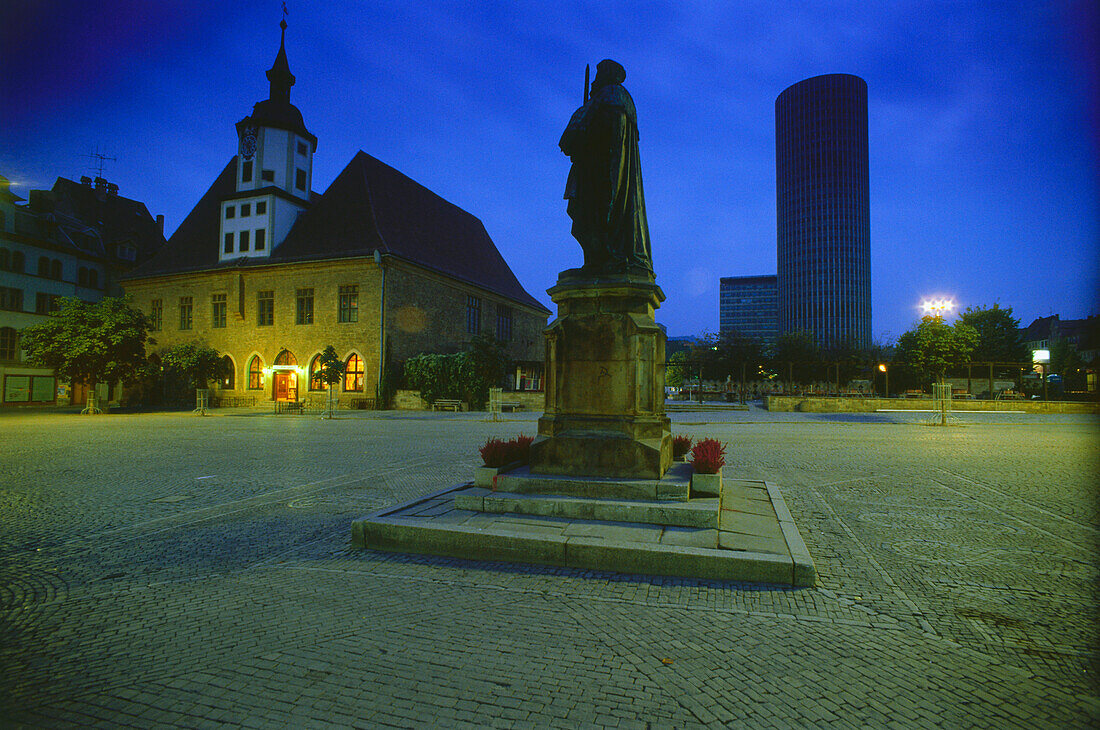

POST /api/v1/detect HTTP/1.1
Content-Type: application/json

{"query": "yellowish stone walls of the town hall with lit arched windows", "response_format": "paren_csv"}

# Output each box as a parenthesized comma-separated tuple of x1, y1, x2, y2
(125, 257, 546, 400)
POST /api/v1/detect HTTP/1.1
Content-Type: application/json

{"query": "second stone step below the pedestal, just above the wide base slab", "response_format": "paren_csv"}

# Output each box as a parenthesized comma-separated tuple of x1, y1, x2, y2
(454, 489, 719, 530)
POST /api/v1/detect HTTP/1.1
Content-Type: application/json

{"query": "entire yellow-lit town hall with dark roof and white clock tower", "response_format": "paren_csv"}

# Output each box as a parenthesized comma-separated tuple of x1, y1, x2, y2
(123, 21, 550, 405)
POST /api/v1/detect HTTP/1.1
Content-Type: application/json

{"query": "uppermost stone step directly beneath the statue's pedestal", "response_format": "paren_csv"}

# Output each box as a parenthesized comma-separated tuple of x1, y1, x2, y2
(496, 464, 692, 501)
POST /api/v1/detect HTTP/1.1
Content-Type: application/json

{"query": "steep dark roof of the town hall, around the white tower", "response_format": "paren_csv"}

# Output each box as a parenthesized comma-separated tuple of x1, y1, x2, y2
(123, 151, 549, 312)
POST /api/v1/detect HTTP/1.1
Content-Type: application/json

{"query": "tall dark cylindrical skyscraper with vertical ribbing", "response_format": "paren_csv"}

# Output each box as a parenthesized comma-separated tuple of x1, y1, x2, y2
(776, 74, 871, 349)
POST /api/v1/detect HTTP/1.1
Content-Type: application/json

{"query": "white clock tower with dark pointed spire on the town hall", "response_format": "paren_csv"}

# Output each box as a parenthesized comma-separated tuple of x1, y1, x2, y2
(218, 18, 317, 261)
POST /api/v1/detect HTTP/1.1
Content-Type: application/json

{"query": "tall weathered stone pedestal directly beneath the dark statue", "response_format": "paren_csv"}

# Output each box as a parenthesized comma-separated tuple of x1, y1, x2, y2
(530, 274, 672, 479)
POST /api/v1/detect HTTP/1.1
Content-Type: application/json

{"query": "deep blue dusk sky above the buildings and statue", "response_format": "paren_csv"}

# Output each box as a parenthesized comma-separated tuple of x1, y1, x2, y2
(0, 0, 1100, 339)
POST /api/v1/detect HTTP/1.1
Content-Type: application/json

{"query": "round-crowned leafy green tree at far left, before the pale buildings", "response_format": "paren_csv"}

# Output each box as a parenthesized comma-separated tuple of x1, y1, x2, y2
(20, 297, 153, 402)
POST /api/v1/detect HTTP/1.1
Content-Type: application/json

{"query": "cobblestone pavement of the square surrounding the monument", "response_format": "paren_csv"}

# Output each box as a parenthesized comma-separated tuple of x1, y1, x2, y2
(0, 410, 1100, 728)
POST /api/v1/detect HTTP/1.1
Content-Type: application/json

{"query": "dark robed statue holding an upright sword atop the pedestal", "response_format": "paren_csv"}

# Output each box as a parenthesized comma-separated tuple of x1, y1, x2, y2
(558, 59, 653, 278)
